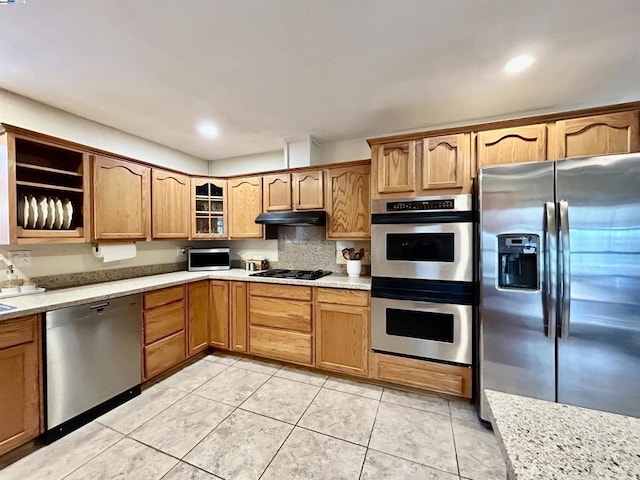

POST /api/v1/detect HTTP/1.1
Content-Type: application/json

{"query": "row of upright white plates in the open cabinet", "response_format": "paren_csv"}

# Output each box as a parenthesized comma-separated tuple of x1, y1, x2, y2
(18, 195, 73, 230)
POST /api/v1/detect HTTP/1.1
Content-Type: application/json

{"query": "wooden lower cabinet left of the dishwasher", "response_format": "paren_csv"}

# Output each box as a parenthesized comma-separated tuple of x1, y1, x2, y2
(0, 315, 43, 454)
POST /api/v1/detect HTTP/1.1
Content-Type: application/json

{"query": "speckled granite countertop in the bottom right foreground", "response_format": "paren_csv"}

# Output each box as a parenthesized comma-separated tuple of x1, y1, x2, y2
(485, 390, 640, 480)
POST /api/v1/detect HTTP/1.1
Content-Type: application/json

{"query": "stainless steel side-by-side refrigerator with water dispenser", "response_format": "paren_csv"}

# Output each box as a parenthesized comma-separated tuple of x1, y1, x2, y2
(479, 154, 640, 420)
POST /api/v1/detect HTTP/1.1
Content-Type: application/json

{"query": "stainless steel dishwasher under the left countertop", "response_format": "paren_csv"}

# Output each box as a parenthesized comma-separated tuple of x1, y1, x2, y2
(45, 295, 142, 440)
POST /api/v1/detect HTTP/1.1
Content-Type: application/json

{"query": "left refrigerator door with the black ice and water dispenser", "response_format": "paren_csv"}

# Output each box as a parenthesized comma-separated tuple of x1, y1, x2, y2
(479, 162, 556, 420)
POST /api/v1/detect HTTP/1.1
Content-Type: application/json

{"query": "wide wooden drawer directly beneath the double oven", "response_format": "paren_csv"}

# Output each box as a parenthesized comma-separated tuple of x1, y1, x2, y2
(371, 353, 471, 398)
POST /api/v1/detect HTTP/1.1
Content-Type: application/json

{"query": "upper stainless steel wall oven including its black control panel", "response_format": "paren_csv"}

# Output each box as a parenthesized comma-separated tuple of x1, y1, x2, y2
(371, 195, 473, 282)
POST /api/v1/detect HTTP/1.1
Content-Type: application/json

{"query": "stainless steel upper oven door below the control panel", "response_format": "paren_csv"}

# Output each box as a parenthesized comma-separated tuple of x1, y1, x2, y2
(371, 223, 473, 282)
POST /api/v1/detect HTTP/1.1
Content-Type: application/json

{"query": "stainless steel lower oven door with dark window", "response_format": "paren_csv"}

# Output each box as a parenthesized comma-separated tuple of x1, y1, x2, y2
(371, 297, 473, 365)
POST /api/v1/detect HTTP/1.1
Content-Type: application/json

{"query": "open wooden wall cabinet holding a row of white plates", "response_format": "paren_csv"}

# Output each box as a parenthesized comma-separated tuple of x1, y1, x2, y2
(0, 125, 90, 245)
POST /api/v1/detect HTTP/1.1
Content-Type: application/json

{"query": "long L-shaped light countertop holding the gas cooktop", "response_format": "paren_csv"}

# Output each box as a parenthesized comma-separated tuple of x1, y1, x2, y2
(0, 268, 371, 322)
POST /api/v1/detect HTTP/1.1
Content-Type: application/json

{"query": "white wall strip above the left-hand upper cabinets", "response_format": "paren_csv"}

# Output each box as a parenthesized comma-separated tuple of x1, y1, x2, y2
(0, 89, 209, 174)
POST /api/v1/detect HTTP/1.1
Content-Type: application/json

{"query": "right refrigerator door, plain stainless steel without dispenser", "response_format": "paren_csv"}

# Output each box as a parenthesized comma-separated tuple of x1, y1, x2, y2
(557, 155, 640, 417)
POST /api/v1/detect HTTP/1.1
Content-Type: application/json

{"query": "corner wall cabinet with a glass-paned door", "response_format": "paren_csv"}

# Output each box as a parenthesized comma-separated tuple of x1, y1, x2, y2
(191, 178, 228, 239)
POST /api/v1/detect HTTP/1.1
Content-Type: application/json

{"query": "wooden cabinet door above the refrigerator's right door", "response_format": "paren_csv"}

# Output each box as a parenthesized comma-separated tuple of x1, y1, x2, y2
(556, 111, 640, 158)
